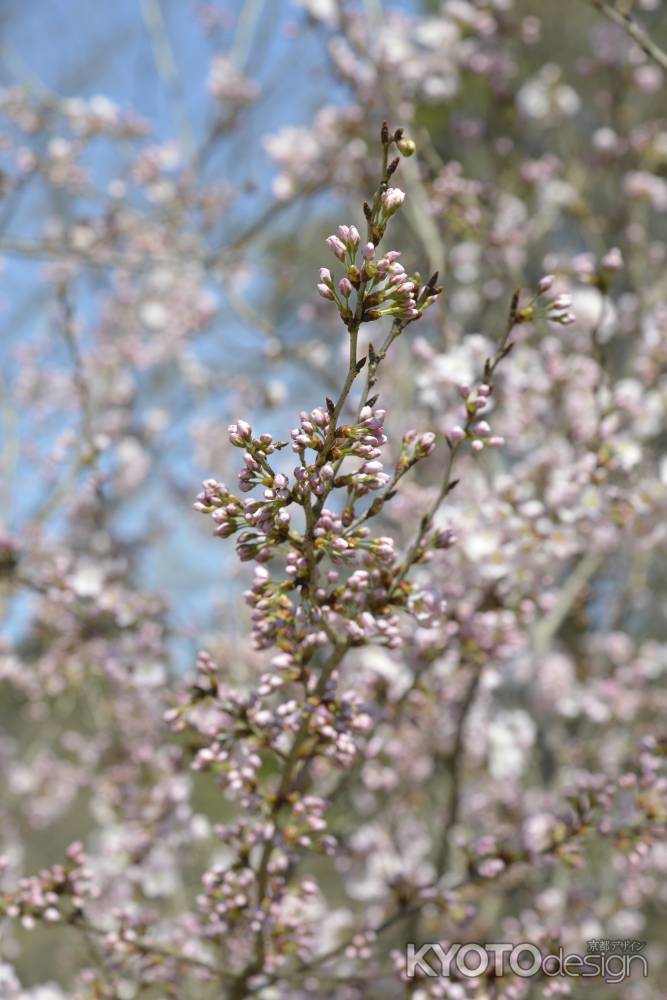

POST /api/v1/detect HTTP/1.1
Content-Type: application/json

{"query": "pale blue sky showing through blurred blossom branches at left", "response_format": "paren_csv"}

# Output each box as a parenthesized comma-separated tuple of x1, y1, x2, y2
(0, 0, 405, 663)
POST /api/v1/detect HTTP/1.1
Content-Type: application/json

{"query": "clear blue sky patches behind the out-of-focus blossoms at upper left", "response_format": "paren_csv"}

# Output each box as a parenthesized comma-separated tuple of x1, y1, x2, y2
(0, 0, 418, 664)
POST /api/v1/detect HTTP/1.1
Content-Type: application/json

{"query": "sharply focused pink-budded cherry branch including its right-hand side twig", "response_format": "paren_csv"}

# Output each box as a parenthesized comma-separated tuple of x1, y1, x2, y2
(183, 125, 569, 997)
